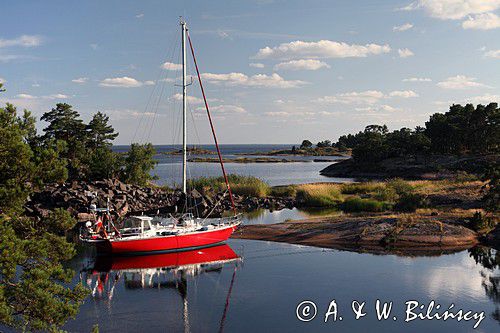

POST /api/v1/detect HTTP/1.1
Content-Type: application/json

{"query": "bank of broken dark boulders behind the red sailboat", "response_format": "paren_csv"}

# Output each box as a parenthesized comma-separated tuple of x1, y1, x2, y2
(25, 179, 296, 221)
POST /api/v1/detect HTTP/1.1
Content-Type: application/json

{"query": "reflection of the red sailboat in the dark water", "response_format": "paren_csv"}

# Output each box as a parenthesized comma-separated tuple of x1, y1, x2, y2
(81, 244, 242, 331)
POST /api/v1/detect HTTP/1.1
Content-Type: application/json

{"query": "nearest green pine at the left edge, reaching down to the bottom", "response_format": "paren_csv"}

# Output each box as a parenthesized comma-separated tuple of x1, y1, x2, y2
(0, 99, 87, 331)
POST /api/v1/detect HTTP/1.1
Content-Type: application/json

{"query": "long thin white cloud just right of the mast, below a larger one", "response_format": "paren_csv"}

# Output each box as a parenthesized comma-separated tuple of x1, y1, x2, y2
(201, 73, 307, 88)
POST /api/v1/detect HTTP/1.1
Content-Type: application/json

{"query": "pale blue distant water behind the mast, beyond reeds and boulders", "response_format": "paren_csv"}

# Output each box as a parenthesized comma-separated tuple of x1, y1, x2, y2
(114, 144, 353, 186)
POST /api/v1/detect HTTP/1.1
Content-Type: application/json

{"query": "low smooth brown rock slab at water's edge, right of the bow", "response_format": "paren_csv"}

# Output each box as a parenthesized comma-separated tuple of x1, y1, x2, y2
(233, 211, 480, 255)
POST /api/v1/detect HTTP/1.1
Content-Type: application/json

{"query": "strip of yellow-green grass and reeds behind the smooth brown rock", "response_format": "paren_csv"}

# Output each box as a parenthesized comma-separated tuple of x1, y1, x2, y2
(189, 174, 482, 213)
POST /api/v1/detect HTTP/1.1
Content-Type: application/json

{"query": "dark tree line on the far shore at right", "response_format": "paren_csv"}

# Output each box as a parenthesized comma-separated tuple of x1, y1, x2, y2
(301, 103, 500, 163)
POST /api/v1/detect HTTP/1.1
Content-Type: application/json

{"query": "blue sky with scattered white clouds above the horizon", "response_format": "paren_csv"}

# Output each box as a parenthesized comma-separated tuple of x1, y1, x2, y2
(0, 0, 500, 144)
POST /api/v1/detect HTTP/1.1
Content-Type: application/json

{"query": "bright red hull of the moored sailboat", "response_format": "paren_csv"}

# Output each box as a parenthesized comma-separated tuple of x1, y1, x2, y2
(96, 225, 237, 254)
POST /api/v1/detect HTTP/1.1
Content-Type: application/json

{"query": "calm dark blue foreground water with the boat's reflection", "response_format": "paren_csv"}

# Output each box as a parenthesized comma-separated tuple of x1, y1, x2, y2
(65, 240, 500, 332)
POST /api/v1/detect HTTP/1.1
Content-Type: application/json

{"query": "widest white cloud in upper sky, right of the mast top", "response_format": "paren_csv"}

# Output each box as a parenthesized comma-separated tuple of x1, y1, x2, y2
(254, 40, 391, 59)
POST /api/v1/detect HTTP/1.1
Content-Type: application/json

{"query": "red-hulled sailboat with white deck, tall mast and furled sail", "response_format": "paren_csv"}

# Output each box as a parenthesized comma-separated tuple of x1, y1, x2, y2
(80, 19, 241, 254)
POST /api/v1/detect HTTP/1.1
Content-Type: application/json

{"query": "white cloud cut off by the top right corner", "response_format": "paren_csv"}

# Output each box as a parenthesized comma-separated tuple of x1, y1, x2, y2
(401, 0, 500, 20)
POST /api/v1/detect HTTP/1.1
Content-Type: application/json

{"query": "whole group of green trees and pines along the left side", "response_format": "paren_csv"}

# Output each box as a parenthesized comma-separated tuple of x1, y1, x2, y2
(0, 85, 158, 331)
